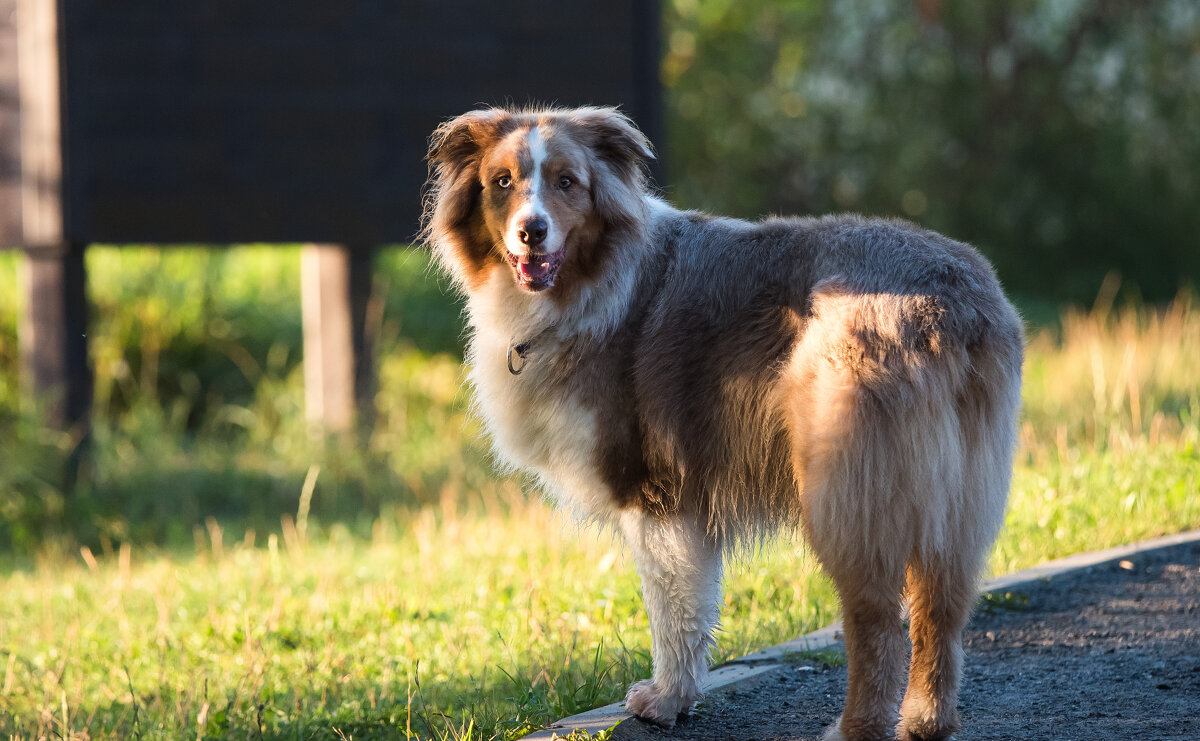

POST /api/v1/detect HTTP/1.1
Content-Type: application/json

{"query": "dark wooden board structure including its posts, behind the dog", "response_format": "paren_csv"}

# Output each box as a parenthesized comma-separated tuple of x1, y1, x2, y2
(0, 0, 660, 428)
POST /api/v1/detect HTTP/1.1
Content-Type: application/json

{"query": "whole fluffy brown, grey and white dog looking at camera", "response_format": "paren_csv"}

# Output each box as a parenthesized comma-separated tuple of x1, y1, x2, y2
(425, 108, 1024, 739)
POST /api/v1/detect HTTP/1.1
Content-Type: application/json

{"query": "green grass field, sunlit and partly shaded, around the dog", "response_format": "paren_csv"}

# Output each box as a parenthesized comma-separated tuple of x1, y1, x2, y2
(0, 248, 1200, 739)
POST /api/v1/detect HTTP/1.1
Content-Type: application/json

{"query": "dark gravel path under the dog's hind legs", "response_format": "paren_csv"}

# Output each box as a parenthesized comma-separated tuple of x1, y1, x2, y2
(612, 542, 1200, 741)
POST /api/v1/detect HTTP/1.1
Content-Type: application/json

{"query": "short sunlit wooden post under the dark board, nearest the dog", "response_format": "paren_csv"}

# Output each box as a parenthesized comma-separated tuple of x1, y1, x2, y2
(300, 245, 376, 432)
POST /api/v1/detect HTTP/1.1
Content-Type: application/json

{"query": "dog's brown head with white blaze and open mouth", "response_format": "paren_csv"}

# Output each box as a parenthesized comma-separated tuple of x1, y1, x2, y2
(424, 108, 654, 293)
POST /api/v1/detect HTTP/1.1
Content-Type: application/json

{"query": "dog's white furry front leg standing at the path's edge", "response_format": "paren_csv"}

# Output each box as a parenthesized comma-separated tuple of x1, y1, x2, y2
(620, 511, 721, 728)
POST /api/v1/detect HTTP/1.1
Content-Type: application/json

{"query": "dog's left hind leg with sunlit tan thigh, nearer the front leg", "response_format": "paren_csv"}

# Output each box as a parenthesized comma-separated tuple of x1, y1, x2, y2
(786, 327, 920, 741)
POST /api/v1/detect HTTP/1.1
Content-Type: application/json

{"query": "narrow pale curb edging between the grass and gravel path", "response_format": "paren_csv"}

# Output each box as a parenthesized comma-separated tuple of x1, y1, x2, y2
(523, 530, 1200, 741)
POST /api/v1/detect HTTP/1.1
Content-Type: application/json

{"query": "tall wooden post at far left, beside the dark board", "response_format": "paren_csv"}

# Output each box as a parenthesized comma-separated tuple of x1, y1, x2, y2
(16, 0, 92, 429)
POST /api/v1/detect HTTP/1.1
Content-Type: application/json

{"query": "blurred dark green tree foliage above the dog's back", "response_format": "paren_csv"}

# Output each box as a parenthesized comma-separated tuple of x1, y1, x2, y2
(662, 0, 1200, 300)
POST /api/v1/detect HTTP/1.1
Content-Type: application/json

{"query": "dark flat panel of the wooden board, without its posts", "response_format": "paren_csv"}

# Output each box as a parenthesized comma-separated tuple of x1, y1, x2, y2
(58, 0, 660, 245)
